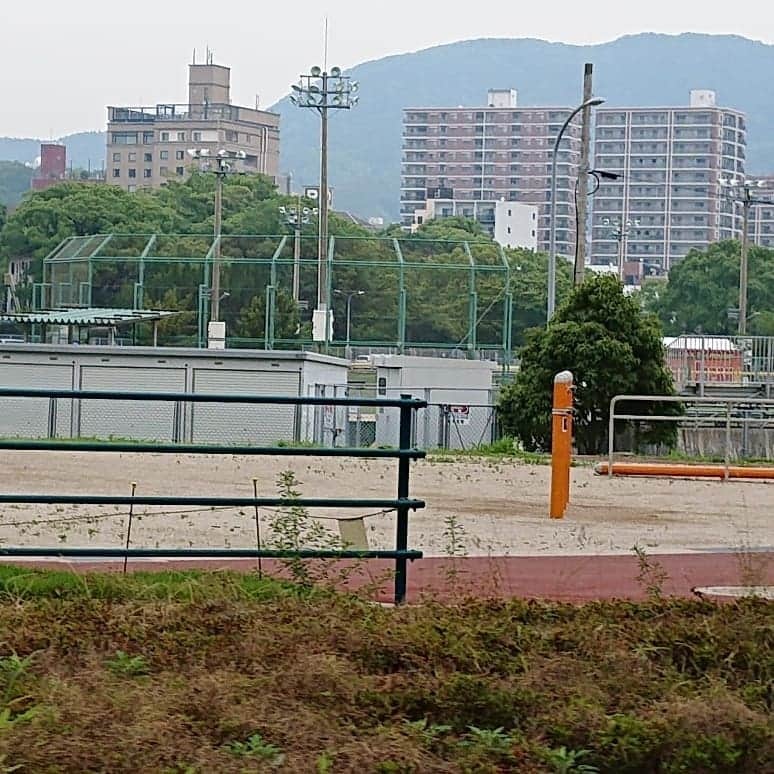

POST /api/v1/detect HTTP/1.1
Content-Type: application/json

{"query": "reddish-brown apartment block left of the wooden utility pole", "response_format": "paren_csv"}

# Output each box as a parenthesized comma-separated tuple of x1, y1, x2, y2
(400, 89, 580, 256)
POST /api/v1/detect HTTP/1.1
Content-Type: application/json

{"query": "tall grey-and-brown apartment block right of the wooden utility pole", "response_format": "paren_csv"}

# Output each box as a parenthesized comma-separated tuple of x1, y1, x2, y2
(591, 91, 747, 284)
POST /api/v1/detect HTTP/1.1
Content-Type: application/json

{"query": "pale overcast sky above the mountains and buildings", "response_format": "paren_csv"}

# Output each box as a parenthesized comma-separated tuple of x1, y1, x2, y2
(0, 0, 774, 138)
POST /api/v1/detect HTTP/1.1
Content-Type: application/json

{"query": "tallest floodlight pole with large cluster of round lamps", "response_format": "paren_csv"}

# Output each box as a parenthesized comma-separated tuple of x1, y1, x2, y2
(290, 67, 359, 344)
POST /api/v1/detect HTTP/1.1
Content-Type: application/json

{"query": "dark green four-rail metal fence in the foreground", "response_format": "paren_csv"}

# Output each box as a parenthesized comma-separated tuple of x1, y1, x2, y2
(0, 388, 426, 604)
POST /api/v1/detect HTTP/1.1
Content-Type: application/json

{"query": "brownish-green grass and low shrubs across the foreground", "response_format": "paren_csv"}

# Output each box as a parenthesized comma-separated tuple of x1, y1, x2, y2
(0, 567, 774, 774)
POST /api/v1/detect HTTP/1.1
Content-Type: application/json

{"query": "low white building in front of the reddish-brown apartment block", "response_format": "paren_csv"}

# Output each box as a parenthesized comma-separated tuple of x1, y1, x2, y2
(411, 199, 538, 250)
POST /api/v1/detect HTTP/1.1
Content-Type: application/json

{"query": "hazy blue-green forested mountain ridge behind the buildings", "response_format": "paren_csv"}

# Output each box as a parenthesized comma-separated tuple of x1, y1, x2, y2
(0, 32, 774, 220)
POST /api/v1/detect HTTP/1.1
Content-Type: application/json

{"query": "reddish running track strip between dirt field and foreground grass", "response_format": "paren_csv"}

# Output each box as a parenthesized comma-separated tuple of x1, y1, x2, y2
(10, 551, 774, 602)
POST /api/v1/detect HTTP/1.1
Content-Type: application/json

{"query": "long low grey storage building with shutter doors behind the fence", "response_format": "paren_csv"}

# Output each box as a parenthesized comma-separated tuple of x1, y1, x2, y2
(0, 344, 348, 445)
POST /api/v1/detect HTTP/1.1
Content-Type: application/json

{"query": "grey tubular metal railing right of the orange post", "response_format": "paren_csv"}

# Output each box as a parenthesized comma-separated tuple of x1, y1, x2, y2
(607, 395, 774, 480)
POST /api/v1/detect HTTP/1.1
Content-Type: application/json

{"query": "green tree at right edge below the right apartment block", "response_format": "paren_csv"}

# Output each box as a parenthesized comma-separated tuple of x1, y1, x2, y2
(643, 242, 774, 335)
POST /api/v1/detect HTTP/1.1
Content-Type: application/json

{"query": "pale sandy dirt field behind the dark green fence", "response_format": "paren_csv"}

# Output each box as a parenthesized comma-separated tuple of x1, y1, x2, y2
(0, 452, 774, 556)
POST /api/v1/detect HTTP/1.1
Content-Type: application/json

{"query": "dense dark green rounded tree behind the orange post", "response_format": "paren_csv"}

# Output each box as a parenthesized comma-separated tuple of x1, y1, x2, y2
(500, 276, 679, 454)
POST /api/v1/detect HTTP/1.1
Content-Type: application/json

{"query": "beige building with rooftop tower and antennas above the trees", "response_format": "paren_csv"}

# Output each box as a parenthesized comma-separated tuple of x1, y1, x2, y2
(106, 63, 279, 191)
